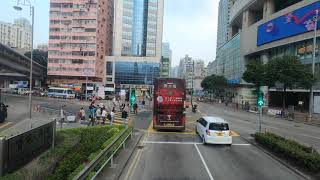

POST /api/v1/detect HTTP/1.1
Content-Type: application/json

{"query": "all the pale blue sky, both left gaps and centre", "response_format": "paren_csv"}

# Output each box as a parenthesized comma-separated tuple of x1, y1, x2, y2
(0, 0, 219, 66)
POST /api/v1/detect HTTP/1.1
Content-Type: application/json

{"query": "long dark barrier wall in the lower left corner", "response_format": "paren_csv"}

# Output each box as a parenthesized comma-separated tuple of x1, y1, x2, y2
(0, 120, 56, 176)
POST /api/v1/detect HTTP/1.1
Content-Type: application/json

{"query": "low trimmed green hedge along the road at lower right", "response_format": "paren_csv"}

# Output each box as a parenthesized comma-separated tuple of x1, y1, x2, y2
(255, 133, 320, 172)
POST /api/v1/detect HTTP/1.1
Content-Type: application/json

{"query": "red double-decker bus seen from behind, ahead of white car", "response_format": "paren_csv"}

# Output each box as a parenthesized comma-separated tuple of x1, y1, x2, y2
(153, 78, 186, 130)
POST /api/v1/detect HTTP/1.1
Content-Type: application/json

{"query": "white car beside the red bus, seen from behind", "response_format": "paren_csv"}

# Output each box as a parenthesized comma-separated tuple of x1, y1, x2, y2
(196, 116, 232, 145)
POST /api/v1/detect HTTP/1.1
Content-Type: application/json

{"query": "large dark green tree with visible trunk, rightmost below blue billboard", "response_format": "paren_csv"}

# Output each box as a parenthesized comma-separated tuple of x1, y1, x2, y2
(265, 56, 315, 110)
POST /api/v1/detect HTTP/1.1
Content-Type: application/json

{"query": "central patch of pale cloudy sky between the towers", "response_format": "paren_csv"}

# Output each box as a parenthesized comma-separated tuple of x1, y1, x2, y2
(164, 0, 218, 65)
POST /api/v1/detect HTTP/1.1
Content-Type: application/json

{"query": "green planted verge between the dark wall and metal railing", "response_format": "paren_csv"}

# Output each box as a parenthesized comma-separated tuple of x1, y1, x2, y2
(1, 126, 123, 180)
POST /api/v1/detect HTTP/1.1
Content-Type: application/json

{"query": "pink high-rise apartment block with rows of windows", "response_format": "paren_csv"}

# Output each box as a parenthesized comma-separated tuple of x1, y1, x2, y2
(48, 0, 114, 84)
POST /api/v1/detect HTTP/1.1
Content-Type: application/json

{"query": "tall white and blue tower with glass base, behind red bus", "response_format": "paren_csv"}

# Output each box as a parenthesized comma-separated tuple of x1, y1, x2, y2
(105, 0, 164, 87)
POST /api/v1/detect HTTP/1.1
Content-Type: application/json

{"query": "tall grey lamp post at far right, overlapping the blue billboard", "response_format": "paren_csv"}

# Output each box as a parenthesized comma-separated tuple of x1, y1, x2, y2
(308, 9, 319, 121)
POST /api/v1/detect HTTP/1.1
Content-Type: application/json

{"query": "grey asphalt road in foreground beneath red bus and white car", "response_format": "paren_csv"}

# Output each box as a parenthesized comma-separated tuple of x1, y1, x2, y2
(120, 105, 302, 180)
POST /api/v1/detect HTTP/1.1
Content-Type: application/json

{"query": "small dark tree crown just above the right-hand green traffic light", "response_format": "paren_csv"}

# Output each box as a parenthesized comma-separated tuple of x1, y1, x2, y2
(242, 61, 266, 90)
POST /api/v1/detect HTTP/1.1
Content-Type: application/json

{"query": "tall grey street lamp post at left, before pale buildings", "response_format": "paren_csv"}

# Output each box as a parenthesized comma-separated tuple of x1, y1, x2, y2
(13, 1, 34, 119)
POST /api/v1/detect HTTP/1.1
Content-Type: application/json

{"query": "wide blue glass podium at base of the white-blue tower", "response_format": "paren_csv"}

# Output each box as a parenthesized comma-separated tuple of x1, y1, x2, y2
(115, 61, 160, 85)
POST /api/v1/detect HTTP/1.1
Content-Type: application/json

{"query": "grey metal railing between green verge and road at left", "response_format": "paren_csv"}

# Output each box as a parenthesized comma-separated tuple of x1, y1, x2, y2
(73, 127, 132, 180)
